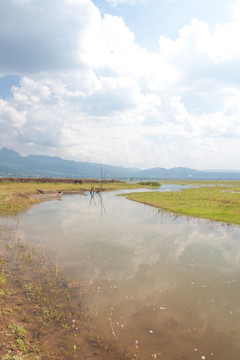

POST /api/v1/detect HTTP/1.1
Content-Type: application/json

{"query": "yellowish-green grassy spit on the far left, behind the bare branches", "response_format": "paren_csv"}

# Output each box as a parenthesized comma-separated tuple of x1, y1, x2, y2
(0, 178, 159, 216)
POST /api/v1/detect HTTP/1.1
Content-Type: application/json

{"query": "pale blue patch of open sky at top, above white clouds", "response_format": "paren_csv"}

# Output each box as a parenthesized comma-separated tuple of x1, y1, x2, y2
(94, 0, 233, 51)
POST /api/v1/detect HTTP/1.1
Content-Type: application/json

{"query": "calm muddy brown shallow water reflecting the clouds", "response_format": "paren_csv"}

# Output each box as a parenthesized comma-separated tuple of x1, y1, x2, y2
(0, 186, 240, 360)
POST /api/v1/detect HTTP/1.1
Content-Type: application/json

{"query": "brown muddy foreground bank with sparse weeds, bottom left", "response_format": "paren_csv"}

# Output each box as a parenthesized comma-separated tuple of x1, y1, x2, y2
(0, 234, 126, 360)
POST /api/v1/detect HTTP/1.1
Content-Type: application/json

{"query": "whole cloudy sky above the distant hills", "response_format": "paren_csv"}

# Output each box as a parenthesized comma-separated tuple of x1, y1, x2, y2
(0, 0, 240, 170)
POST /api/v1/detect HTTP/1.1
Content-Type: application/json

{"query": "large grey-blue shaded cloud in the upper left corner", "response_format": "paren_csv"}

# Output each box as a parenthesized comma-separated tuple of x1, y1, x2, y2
(0, 0, 98, 74)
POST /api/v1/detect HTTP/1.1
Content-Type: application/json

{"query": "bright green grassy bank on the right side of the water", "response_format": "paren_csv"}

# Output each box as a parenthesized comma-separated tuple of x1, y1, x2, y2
(125, 181, 240, 225)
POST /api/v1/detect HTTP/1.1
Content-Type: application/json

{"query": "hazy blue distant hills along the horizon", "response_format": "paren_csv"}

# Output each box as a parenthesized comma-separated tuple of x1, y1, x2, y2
(0, 147, 240, 180)
